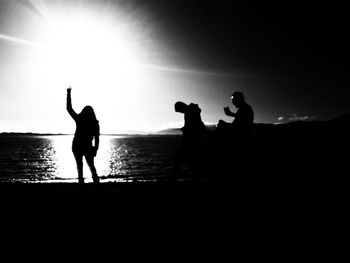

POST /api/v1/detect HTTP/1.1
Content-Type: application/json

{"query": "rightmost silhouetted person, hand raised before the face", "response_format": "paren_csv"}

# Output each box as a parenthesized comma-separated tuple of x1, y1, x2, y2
(215, 91, 254, 177)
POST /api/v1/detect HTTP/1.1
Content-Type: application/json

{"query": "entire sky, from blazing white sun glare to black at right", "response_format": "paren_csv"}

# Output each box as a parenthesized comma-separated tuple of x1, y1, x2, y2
(0, 0, 350, 133)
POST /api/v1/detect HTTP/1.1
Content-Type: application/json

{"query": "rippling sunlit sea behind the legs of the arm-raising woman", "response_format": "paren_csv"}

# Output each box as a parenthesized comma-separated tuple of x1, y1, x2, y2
(0, 135, 186, 182)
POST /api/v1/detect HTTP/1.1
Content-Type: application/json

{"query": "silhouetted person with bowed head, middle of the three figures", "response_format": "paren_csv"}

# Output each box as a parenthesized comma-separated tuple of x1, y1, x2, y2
(171, 101, 205, 181)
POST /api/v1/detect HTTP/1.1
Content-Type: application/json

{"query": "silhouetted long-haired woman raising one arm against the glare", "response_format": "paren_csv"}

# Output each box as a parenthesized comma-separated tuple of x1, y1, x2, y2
(67, 87, 100, 184)
